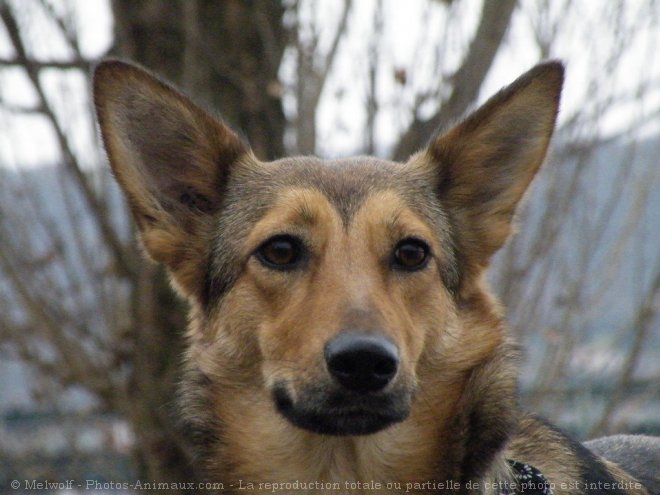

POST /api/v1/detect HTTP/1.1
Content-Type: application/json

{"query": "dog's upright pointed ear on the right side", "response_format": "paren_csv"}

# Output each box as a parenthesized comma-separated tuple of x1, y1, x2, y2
(412, 62, 564, 282)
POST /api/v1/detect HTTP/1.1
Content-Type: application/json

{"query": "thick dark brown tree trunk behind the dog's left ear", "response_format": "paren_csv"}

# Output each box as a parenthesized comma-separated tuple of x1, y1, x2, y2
(107, 0, 286, 481)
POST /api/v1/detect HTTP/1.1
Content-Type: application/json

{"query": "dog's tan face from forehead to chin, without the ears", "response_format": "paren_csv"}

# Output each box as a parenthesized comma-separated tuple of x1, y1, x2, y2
(211, 158, 457, 434)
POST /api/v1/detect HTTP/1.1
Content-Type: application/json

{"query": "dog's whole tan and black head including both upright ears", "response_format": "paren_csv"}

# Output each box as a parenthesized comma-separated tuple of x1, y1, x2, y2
(95, 62, 562, 435)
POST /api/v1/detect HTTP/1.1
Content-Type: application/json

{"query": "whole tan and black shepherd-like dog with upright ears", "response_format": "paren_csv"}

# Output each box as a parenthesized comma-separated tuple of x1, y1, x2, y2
(94, 60, 660, 495)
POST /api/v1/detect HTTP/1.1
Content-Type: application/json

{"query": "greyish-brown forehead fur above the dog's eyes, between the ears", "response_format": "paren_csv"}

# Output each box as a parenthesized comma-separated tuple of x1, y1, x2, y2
(218, 157, 448, 237)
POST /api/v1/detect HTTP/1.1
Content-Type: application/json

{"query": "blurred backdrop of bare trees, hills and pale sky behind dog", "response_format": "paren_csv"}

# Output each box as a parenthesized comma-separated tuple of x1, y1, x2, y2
(0, 0, 660, 490)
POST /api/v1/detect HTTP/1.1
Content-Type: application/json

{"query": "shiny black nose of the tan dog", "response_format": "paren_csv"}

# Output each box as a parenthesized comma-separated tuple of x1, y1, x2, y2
(325, 332, 399, 392)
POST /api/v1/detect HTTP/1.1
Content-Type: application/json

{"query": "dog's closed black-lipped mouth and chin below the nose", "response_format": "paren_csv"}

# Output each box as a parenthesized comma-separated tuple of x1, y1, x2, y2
(273, 384, 412, 436)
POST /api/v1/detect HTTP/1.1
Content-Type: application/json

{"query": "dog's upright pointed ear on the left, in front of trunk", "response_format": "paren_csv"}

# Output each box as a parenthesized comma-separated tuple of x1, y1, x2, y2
(94, 60, 249, 300)
